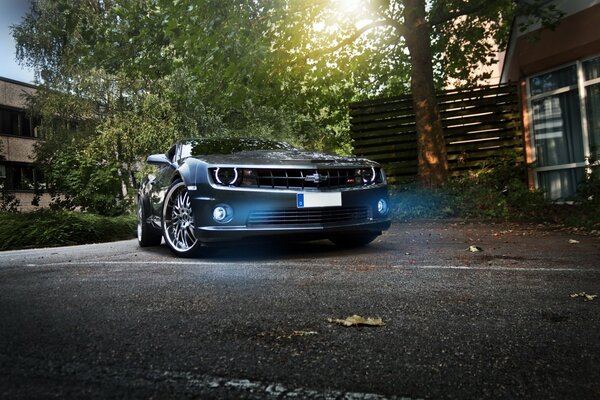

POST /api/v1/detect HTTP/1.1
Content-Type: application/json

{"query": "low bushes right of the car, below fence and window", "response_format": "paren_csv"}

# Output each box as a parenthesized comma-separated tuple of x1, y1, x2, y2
(390, 158, 600, 231)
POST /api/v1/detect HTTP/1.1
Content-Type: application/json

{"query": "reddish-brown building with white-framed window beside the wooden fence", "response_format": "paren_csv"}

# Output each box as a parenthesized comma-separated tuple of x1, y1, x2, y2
(501, 0, 600, 200)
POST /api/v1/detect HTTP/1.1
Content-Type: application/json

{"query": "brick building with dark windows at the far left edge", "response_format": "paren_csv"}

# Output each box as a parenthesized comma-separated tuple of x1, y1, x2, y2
(0, 77, 50, 211)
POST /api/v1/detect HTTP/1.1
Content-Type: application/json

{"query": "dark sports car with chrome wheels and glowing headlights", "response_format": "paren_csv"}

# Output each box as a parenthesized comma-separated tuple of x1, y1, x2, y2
(137, 138, 390, 256)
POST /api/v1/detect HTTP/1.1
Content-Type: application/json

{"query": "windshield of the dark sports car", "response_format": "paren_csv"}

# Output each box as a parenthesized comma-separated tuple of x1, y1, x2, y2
(181, 138, 295, 158)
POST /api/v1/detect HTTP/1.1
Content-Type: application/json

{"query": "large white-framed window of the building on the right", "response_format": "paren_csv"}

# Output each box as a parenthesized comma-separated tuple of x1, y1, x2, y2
(528, 57, 600, 200)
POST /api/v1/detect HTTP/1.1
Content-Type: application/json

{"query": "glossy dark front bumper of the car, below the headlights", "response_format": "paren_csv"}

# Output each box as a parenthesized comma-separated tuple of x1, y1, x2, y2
(190, 184, 391, 245)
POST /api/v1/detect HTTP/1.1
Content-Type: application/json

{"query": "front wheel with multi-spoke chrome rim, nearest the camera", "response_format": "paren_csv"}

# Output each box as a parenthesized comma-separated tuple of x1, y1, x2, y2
(162, 180, 202, 257)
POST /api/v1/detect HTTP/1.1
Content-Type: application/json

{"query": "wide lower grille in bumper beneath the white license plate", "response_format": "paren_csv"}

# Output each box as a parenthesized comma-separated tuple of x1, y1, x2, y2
(248, 207, 369, 226)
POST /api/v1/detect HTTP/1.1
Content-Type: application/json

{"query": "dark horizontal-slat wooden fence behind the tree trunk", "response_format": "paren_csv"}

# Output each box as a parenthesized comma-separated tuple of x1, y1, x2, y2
(350, 84, 524, 181)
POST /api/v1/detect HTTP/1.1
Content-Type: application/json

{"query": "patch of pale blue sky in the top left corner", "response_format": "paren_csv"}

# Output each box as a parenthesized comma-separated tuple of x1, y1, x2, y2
(0, 0, 33, 83)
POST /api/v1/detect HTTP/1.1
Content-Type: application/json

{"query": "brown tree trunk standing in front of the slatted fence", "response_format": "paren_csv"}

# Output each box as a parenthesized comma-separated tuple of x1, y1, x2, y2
(404, 0, 448, 187)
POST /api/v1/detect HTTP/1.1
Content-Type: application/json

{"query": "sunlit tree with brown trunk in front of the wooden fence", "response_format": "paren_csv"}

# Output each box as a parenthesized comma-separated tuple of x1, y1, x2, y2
(278, 0, 560, 186)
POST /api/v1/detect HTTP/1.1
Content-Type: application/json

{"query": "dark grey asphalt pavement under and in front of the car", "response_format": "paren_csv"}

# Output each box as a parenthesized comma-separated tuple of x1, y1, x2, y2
(0, 222, 600, 399)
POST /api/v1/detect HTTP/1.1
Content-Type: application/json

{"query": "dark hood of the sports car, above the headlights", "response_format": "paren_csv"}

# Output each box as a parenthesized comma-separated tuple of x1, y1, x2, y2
(194, 150, 379, 168)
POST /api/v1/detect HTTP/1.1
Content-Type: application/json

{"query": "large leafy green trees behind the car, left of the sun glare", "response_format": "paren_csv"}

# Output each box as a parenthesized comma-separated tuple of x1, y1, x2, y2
(13, 0, 317, 214)
